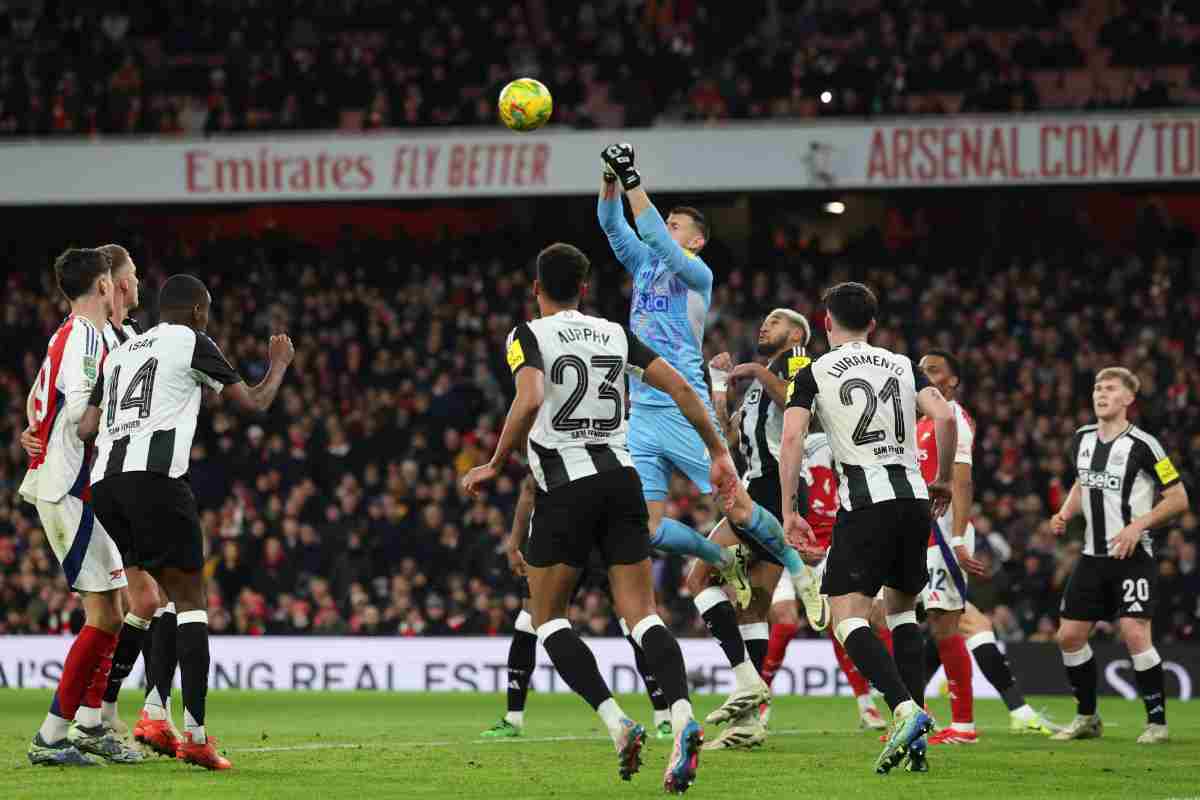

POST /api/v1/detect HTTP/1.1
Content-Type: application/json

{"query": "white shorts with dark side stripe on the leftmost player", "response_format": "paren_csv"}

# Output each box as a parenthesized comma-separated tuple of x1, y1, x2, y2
(37, 494, 127, 591)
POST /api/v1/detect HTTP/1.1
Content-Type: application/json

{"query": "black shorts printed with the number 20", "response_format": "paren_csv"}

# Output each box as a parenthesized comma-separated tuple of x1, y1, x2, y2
(1060, 547, 1158, 622)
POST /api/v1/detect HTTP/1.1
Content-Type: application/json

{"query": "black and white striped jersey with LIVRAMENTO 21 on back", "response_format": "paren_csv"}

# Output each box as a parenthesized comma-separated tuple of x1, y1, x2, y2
(787, 342, 929, 511)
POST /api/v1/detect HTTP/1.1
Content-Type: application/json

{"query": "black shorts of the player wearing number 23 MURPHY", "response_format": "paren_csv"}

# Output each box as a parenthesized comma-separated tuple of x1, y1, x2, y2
(527, 467, 650, 570)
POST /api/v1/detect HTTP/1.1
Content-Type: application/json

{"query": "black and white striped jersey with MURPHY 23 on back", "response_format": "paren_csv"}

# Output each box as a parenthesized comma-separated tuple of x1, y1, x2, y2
(506, 311, 659, 492)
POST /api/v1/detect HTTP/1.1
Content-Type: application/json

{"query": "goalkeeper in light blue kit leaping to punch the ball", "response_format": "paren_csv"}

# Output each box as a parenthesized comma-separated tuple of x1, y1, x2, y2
(596, 143, 750, 599)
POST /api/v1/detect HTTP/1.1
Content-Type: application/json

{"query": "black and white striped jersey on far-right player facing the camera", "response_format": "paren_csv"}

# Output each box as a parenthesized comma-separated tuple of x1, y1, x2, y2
(1070, 425, 1180, 557)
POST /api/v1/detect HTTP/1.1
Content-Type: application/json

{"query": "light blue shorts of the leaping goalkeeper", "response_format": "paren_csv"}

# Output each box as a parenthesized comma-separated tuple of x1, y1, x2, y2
(626, 405, 716, 501)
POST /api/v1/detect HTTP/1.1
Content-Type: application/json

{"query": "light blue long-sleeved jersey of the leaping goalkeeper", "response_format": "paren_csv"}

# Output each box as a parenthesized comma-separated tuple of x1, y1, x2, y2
(596, 197, 713, 409)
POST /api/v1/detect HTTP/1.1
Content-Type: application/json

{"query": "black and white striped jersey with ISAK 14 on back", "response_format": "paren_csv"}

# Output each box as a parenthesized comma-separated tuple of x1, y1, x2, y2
(90, 323, 241, 485)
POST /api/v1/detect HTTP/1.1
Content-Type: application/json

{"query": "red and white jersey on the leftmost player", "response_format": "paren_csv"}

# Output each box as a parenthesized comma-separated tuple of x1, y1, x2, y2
(20, 314, 104, 503)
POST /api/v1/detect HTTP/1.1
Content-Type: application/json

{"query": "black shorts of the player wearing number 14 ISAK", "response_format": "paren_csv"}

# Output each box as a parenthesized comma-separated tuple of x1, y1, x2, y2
(91, 473, 204, 571)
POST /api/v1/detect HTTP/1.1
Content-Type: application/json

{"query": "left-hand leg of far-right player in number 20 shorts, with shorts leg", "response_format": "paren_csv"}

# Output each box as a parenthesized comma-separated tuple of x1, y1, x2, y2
(1052, 555, 1099, 741)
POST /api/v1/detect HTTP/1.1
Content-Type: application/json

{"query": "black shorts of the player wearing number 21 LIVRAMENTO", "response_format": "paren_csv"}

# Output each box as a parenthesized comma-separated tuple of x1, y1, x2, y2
(821, 500, 932, 597)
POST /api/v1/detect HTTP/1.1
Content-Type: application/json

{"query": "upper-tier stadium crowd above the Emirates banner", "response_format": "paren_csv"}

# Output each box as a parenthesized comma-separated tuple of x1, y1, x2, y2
(0, 0, 1200, 136)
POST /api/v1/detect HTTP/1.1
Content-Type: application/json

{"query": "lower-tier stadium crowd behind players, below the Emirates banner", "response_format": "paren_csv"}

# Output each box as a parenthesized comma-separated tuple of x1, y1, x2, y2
(0, 194, 1200, 642)
